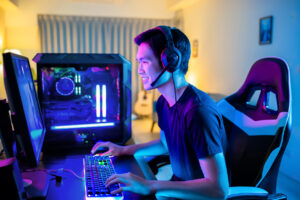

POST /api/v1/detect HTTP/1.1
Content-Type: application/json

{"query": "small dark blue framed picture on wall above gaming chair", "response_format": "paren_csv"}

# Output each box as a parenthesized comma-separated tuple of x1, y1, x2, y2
(259, 16, 273, 44)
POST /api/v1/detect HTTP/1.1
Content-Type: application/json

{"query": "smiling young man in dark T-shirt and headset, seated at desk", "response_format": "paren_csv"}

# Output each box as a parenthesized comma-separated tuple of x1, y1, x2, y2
(92, 26, 228, 199)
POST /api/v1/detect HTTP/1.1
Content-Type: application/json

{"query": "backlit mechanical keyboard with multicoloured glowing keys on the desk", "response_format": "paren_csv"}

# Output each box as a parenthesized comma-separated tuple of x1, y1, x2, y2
(83, 155, 123, 200)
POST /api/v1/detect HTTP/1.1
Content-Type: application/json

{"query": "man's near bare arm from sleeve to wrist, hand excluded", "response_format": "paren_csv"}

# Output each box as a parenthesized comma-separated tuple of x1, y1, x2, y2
(154, 153, 229, 200)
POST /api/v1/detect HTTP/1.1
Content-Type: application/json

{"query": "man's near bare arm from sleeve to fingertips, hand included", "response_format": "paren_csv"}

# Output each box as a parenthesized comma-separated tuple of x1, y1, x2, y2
(106, 153, 229, 200)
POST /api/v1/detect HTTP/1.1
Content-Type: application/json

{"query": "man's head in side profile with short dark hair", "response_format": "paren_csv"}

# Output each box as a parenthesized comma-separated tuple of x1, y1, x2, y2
(135, 26, 191, 90)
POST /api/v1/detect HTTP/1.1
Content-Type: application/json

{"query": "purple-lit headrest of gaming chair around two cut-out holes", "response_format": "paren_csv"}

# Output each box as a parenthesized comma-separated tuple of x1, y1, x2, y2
(226, 57, 290, 120)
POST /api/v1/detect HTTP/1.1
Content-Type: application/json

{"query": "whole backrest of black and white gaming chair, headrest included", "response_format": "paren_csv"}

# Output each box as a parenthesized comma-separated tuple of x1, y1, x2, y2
(218, 57, 291, 193)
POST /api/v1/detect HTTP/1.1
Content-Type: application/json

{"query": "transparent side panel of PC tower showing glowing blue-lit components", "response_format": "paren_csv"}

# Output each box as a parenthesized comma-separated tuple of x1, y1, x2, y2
(41, 65, 120, 129)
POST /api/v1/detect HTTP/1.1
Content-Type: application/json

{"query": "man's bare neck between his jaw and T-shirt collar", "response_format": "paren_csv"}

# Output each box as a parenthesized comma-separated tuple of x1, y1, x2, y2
(157, 73, 188, 107)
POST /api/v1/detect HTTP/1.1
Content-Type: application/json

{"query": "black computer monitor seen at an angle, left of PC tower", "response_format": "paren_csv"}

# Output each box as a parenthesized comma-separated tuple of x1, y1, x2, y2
(3, 53, 45, 166)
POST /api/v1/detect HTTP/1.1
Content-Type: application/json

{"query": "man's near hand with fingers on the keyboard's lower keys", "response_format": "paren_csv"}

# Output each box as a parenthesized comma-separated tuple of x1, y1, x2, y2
(105, 172, 154, 195)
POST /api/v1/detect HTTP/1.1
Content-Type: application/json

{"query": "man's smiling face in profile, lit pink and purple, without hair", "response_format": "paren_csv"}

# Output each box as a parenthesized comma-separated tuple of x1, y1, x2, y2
(136, 42, 162, 90)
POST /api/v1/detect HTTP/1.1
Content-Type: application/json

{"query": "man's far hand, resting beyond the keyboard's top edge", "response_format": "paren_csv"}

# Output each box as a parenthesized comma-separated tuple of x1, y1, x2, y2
(91, 142, 124, 156)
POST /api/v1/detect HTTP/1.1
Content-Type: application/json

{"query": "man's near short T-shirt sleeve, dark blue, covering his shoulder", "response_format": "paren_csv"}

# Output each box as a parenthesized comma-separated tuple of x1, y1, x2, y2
(186, 106, 223, 159)
